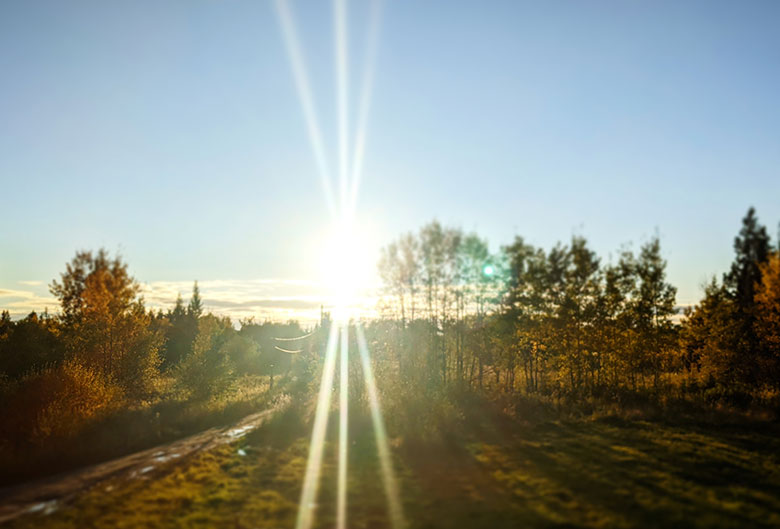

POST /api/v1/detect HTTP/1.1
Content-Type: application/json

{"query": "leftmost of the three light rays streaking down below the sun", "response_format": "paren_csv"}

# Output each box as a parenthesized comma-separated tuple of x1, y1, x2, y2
(295, 325, 339, 529)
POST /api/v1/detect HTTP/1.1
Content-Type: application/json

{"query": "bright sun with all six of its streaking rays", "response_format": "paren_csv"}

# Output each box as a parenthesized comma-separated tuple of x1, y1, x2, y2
(275, 0, 405, 529)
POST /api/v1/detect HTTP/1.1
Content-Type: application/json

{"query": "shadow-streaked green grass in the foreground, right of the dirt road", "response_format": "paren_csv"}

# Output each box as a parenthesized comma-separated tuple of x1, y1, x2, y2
(12, 399, 780, 528)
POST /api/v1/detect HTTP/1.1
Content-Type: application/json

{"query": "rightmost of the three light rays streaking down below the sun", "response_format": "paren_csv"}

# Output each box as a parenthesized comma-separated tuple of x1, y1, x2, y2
(356, 323, 405, 529)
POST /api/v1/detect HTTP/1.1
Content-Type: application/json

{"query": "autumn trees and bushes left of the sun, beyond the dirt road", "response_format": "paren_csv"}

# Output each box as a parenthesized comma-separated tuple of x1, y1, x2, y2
(0, 250, 314, 453)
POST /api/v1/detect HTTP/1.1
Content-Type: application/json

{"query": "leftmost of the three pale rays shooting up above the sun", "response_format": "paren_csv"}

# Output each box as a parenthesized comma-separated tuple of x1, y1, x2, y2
(274, 0, 336, 216)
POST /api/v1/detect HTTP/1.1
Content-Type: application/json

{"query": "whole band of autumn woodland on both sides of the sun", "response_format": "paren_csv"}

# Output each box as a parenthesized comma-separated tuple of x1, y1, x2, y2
(0, 208, 780, 526)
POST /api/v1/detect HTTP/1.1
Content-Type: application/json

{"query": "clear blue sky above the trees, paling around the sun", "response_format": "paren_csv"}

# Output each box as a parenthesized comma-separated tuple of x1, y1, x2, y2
(0, 0, 780, 318)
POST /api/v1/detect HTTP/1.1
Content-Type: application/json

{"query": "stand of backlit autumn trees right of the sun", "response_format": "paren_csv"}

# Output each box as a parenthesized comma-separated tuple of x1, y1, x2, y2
(375, 208, 780, 404)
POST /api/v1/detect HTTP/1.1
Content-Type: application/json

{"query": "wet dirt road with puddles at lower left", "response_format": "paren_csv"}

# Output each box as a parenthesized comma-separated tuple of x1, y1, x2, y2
(0, 409, 277, 524)
